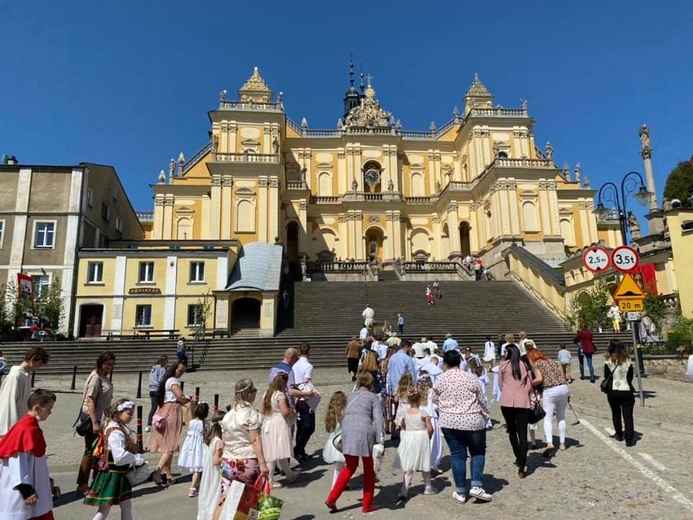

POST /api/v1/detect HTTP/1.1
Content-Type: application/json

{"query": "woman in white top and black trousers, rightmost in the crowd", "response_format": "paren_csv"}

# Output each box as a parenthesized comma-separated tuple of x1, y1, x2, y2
(602, 341, 635, 447)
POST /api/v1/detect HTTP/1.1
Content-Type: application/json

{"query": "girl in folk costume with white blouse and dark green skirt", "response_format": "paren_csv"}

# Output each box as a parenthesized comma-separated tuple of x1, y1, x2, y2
(84, 399, 144, 520)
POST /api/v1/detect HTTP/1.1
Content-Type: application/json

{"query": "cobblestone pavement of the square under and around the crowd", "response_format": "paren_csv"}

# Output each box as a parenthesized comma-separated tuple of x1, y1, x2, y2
(36, 358, 693, 520)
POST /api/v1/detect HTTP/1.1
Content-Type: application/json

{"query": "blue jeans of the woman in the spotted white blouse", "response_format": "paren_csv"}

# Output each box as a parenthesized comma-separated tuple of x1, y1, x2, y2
(442, 428, 486, 493)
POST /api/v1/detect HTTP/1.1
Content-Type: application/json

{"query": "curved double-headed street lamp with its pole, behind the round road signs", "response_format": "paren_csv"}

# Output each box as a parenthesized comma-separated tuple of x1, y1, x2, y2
(594, 172, 654, 396)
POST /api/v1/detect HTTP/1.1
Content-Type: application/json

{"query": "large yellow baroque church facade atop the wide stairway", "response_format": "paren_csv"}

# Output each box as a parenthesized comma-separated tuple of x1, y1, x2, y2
(145, 67, 604, 266)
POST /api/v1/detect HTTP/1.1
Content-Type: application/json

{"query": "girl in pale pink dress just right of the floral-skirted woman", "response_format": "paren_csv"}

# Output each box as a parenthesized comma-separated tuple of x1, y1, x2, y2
(262, 372, 299, 488)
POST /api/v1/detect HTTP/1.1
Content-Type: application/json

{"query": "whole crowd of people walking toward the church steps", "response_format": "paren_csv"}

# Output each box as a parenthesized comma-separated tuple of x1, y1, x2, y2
(0, 322, 635, 520)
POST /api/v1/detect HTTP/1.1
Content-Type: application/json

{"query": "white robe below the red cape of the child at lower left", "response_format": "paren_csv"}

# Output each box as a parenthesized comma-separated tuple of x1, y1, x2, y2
(0, 452, 53, 520)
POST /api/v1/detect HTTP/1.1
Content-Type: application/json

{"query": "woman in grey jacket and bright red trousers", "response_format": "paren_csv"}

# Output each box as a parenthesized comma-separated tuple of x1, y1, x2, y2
(325, 372, 384, 513)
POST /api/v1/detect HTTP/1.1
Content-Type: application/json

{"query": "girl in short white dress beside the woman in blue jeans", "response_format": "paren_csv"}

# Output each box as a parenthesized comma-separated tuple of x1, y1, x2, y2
(393, 387, 436, 500)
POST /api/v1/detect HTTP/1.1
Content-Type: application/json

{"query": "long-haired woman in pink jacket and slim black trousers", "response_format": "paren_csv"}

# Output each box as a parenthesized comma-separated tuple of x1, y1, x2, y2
(498, 344, 533, 478)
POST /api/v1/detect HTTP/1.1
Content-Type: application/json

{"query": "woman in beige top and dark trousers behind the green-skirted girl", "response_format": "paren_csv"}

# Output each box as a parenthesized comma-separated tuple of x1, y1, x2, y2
(77, 350, 115, 495)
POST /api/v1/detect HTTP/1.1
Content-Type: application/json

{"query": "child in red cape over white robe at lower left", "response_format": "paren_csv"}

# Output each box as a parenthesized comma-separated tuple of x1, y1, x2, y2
(0, 389, 56, 520)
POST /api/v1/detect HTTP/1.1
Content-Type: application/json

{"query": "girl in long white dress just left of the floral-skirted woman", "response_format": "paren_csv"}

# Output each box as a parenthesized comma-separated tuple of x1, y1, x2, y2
(197, 412, 224, 520)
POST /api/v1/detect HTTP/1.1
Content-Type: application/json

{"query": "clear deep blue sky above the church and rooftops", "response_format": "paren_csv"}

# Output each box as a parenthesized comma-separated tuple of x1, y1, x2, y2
(0, 0, 693, 224)
